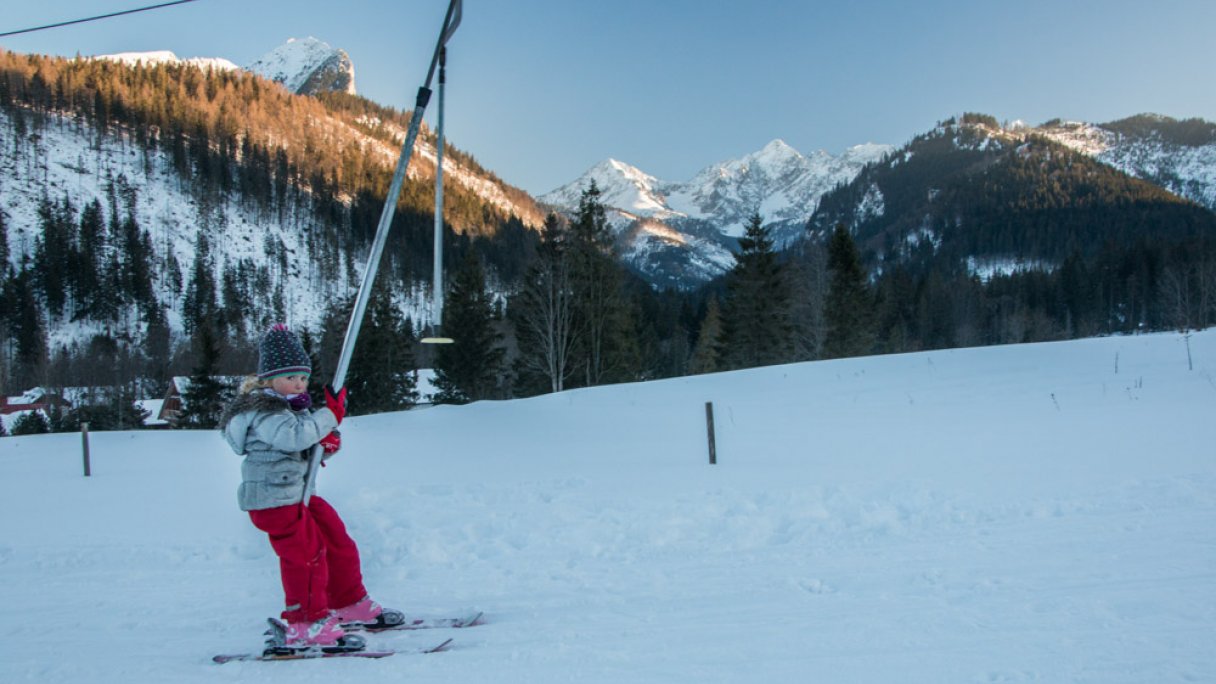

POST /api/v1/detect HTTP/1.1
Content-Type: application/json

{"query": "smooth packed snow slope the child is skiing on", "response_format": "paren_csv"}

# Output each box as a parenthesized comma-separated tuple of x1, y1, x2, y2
(0, 331, 1216, 684)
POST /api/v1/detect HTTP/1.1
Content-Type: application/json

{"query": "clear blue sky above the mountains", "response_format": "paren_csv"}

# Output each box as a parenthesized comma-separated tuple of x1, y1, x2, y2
(0, 0, 1216, 194)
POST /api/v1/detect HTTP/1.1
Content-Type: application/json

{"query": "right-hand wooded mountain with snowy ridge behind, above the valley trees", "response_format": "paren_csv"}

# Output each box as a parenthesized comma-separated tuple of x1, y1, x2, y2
(807, 114, 1216, 277)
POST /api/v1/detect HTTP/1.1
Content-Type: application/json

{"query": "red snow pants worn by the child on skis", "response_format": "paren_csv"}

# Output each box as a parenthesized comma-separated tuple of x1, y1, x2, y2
(249, 497, 367, 622)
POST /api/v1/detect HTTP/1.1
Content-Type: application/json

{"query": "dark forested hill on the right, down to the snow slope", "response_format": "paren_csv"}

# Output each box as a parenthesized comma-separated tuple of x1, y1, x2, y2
(809, 114, 1216, 351)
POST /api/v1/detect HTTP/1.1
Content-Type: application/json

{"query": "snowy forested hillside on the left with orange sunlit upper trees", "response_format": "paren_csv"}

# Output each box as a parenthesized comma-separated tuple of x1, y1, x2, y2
(0, 52, 541, 404)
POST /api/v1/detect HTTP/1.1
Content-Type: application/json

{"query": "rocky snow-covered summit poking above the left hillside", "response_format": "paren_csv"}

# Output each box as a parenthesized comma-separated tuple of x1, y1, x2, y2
(246, 37, 355, 95)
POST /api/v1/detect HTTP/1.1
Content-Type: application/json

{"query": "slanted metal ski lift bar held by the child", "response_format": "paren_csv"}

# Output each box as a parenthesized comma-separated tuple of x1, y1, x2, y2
(304, 0, 462, 506)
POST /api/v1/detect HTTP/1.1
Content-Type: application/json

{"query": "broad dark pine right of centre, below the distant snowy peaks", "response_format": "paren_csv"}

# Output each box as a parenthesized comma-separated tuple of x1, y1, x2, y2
(719, 214, 794, 369)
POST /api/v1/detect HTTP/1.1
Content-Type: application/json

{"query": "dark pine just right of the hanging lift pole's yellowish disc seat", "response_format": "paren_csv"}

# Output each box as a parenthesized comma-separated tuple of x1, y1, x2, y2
(434, 250, 506, 404)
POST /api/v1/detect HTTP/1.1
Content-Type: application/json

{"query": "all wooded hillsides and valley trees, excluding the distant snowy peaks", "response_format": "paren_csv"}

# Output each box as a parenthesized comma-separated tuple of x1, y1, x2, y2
(0, 52, 1216, 430)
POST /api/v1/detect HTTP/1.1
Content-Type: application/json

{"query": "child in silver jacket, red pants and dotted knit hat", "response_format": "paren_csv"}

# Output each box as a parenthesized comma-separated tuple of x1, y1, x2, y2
(220, 324, 404, 650)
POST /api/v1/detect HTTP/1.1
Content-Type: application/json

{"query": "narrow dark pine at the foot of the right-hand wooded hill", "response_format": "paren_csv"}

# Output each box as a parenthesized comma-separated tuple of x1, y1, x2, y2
(823, 224, 874, 359)
